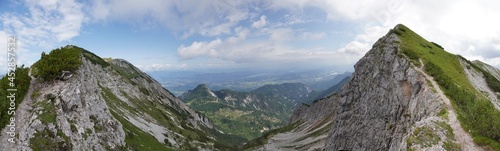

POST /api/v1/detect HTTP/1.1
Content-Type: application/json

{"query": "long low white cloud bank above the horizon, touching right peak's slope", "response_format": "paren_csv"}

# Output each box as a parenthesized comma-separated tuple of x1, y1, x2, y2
(177, 24, 376, 70)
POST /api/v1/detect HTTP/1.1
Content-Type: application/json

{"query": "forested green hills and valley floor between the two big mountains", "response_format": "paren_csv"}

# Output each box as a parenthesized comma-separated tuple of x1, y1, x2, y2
(180, 83, 315, 143)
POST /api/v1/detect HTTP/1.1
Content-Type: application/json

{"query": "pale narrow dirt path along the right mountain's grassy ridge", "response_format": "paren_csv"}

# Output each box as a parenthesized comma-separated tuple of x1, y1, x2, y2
(415, 60, 483, 151)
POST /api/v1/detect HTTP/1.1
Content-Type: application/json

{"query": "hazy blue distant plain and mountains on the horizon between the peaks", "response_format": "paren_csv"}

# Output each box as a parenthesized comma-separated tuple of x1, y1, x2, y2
(148, 69, 352, 96)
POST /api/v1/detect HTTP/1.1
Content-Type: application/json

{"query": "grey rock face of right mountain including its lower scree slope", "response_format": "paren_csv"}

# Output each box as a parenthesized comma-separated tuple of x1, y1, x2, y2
(260, 27, 450, 150)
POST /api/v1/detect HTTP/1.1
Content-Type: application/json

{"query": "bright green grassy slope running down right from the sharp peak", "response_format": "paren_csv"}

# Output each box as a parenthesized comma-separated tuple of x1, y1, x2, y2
(392, 25, 500, 150)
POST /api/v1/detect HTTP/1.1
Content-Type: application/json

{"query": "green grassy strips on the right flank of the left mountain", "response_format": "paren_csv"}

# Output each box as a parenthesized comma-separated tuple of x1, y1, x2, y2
(100, 72, 240, 150)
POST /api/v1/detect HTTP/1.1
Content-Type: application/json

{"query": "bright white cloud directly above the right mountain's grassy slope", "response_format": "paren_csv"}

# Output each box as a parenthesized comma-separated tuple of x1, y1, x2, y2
(380, 0, 500, 67)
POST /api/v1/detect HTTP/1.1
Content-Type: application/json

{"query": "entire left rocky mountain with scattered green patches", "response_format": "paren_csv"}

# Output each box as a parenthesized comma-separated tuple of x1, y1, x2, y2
(0, 46, 236, 150)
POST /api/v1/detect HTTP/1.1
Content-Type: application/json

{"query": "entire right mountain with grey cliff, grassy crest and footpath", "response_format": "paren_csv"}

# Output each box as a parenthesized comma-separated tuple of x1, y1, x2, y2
(244, 25, 500, 150)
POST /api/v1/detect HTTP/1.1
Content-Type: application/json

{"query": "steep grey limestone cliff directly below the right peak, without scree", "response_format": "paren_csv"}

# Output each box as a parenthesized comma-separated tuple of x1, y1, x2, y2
(325, 31, 441, 150)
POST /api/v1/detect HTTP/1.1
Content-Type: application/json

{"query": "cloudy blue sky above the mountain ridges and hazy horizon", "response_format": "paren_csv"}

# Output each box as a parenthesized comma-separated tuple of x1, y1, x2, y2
(0, 0, 500, 72)
